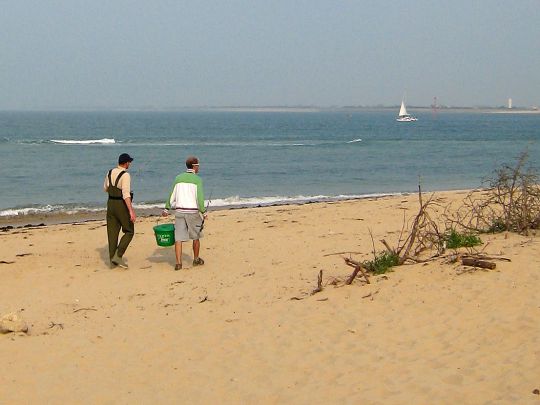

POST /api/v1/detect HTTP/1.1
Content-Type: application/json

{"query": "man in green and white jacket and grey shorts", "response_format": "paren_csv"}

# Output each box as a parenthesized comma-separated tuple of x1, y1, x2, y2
(163, 156, 206, 270)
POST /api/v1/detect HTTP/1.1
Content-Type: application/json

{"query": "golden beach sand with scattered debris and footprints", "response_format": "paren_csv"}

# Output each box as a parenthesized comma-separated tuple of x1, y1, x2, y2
(0, 192, 540, 404)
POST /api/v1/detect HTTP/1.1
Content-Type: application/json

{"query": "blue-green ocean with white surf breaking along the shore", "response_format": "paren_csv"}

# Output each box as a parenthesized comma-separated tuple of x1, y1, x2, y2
(0, 109, 540, 217)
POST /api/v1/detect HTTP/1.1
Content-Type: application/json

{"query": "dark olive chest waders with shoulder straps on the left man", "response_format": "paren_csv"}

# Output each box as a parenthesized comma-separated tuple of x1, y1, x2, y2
(107, 170, 135, 259)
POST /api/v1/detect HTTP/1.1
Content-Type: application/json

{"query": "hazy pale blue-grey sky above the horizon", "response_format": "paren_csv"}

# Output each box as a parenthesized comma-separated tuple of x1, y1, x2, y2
(0, 0, 540, 109)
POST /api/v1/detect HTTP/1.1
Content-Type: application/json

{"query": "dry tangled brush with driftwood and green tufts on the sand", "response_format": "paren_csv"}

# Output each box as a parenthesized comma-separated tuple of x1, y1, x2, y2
(330, 152, 540, 284)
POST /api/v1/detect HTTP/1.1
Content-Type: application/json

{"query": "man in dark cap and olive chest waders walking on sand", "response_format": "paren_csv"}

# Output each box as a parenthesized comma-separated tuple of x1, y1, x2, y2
(103, 153, 137, 269)
